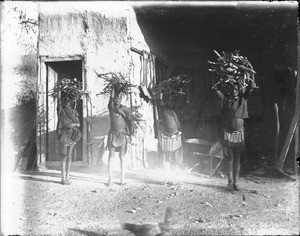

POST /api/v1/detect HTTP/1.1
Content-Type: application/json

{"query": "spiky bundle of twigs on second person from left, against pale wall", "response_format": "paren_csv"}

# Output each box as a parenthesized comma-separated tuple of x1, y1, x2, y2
(96, 72, 135, 95)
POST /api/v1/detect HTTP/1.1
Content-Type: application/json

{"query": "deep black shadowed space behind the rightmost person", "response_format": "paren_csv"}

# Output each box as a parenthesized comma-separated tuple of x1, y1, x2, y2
(134, 2, 298, 171)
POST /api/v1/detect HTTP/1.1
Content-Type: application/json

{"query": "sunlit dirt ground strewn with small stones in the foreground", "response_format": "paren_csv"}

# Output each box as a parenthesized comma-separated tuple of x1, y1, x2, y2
(2, 156, 300, 236)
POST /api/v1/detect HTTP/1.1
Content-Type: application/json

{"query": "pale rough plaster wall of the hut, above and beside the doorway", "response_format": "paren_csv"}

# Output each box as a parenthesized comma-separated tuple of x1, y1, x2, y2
(39, 3, 154, 164)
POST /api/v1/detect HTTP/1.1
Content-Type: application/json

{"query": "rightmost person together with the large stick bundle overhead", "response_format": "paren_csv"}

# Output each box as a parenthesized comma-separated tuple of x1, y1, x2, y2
(209, 51, 257, 191)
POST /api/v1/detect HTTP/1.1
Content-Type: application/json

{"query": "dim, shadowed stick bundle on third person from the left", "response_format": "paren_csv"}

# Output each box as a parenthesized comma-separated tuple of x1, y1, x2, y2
(152, 75, 190, 97)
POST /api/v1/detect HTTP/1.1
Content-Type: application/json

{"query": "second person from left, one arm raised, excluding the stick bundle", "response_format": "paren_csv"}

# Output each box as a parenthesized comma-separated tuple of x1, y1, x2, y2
(107, 88, 132, 186)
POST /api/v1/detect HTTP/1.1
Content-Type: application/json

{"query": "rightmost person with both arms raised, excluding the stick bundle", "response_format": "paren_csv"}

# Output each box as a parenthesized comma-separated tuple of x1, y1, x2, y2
(214, 81, 254, 191)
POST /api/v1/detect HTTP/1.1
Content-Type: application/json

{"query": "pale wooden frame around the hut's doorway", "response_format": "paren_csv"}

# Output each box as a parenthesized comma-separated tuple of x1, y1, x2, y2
(36, 55, 87, 169)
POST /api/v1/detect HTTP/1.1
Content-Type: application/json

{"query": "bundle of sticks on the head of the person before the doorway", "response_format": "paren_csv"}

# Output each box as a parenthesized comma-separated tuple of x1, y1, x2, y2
(49, 78, 84, 105)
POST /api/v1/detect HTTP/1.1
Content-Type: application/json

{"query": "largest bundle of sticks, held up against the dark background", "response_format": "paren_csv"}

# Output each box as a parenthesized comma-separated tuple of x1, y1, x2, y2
(208, 50, 258, 92)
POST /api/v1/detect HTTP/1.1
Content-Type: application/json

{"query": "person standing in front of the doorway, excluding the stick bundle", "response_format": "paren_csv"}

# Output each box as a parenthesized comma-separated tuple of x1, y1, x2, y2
(56, 98, 82, 185)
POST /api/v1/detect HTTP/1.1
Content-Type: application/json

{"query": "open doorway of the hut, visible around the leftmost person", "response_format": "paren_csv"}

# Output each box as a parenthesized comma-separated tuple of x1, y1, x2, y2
(46, 60, 83, 161)
